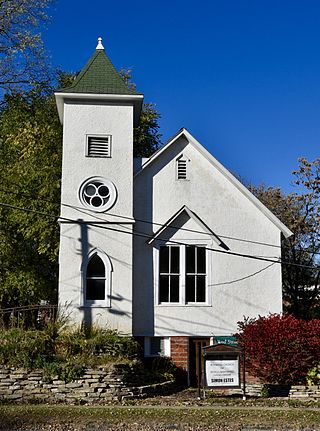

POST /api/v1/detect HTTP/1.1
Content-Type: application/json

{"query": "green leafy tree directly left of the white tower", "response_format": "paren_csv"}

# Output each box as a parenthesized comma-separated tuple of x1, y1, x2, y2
(0, 91, 62, 307)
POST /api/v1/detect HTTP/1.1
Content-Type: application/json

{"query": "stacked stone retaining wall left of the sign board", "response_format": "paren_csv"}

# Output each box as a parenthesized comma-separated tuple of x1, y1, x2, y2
(0, 367, 175, 404)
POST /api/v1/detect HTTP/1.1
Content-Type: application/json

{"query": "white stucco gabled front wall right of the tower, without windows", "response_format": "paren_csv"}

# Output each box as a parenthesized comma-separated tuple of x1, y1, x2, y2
(133, 138, 282, 336)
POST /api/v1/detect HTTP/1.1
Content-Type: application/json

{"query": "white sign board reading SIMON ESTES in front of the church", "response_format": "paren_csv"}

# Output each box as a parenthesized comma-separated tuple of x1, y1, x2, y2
(202, 344, 240, 389)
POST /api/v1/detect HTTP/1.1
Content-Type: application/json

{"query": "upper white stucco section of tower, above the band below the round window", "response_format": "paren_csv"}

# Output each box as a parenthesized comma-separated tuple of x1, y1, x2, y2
(61, 102, 133, 222)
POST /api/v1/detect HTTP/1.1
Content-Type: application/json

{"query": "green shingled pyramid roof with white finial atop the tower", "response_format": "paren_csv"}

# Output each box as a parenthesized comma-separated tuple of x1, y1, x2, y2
(58, 38, 138, 95)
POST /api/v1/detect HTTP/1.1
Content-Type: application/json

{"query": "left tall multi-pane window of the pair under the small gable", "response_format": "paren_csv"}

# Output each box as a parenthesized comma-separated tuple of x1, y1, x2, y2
(159, 246, 180, 303)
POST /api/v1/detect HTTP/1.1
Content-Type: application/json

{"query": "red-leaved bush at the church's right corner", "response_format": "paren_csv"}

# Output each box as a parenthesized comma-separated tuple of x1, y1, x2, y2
(237, 314, 320, 384)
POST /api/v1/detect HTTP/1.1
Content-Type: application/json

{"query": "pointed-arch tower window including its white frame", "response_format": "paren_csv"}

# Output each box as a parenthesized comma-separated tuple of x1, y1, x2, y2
(83, 250, 112, 307)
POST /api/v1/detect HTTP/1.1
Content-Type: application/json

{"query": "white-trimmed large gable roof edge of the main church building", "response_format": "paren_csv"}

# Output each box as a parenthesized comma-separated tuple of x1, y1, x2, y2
(136, 128, 292, 238)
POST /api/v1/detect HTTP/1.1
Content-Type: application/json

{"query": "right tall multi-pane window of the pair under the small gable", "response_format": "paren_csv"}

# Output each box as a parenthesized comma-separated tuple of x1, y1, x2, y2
(186, 246, 206, 303)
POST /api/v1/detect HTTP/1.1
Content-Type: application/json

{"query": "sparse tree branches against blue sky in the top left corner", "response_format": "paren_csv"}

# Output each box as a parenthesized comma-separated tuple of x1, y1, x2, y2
(0, 0, 52, 91)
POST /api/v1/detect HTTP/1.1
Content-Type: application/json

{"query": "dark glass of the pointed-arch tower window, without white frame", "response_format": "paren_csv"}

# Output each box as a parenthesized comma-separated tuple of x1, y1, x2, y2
(86, 254, 106, 301)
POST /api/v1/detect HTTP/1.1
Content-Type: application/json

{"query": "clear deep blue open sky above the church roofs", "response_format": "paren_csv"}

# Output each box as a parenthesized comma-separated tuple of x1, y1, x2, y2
(43, 0, 320, 192)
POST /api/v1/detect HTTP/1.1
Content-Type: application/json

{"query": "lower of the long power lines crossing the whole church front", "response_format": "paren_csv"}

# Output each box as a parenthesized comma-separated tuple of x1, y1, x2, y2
(0, 202, 320, 271)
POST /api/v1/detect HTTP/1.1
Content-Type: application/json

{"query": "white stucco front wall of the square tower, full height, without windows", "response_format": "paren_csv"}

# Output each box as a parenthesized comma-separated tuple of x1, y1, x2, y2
(59, 101, 133, 333)
